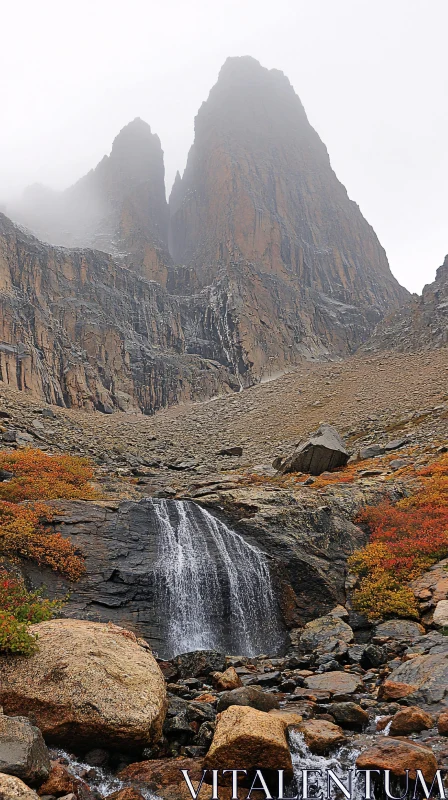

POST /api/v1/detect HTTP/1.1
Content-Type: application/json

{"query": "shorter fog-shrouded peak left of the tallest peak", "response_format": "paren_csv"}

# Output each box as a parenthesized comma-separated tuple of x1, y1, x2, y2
(13, 119, 170, 285)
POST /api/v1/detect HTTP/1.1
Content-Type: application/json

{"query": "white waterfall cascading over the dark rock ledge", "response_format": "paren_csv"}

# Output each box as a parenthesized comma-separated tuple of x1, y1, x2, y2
(147, 499, 283, 657)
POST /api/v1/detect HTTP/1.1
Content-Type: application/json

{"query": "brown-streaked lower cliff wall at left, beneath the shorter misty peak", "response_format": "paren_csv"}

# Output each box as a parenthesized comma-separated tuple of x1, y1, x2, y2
(0, 214, 240, 413)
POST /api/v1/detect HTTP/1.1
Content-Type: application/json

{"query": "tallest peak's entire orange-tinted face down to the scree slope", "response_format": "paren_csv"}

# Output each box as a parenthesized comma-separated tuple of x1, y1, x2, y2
(170, 57, 407, 374)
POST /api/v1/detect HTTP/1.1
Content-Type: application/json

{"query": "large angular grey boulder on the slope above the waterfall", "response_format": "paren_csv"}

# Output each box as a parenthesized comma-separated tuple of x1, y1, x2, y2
(279, 423, 349, 475)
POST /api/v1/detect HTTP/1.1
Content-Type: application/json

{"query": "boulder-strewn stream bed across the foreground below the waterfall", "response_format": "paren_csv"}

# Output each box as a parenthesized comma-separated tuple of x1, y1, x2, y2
(0, 606, 448, 800)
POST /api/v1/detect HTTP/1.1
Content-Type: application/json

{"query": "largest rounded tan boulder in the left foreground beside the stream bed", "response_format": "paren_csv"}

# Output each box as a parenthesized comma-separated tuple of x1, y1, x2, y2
(0, 619, 166, 751)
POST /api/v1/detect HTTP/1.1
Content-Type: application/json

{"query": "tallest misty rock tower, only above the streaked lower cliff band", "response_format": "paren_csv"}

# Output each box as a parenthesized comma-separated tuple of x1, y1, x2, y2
(170, 57, 406, 324)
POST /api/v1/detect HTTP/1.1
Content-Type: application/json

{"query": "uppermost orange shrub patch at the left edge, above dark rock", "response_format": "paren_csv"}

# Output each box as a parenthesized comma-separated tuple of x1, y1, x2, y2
(0, 447, 97, 503)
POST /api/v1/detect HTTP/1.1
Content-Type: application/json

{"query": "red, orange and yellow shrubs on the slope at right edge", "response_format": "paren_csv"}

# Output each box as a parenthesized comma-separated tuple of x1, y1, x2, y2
(349, 456, 448, 621)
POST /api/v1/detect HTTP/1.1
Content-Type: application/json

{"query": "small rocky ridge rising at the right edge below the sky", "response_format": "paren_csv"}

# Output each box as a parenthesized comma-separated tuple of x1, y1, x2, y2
(363, 255, 448, 353)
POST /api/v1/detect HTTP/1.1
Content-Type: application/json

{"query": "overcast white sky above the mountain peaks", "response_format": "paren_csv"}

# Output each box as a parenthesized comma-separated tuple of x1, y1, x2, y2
(0, 0, 448, 291)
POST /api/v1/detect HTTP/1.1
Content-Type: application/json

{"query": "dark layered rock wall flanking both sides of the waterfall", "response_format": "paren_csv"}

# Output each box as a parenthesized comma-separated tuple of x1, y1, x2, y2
(18, 500, 364, 656)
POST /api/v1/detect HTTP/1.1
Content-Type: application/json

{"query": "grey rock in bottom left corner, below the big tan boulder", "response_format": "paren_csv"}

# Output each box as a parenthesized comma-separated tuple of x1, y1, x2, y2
(0, 714, 50, 786)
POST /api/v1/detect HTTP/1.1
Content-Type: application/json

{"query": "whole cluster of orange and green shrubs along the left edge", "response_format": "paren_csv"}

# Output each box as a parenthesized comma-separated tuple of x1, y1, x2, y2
(0, 448, 93, 655)
